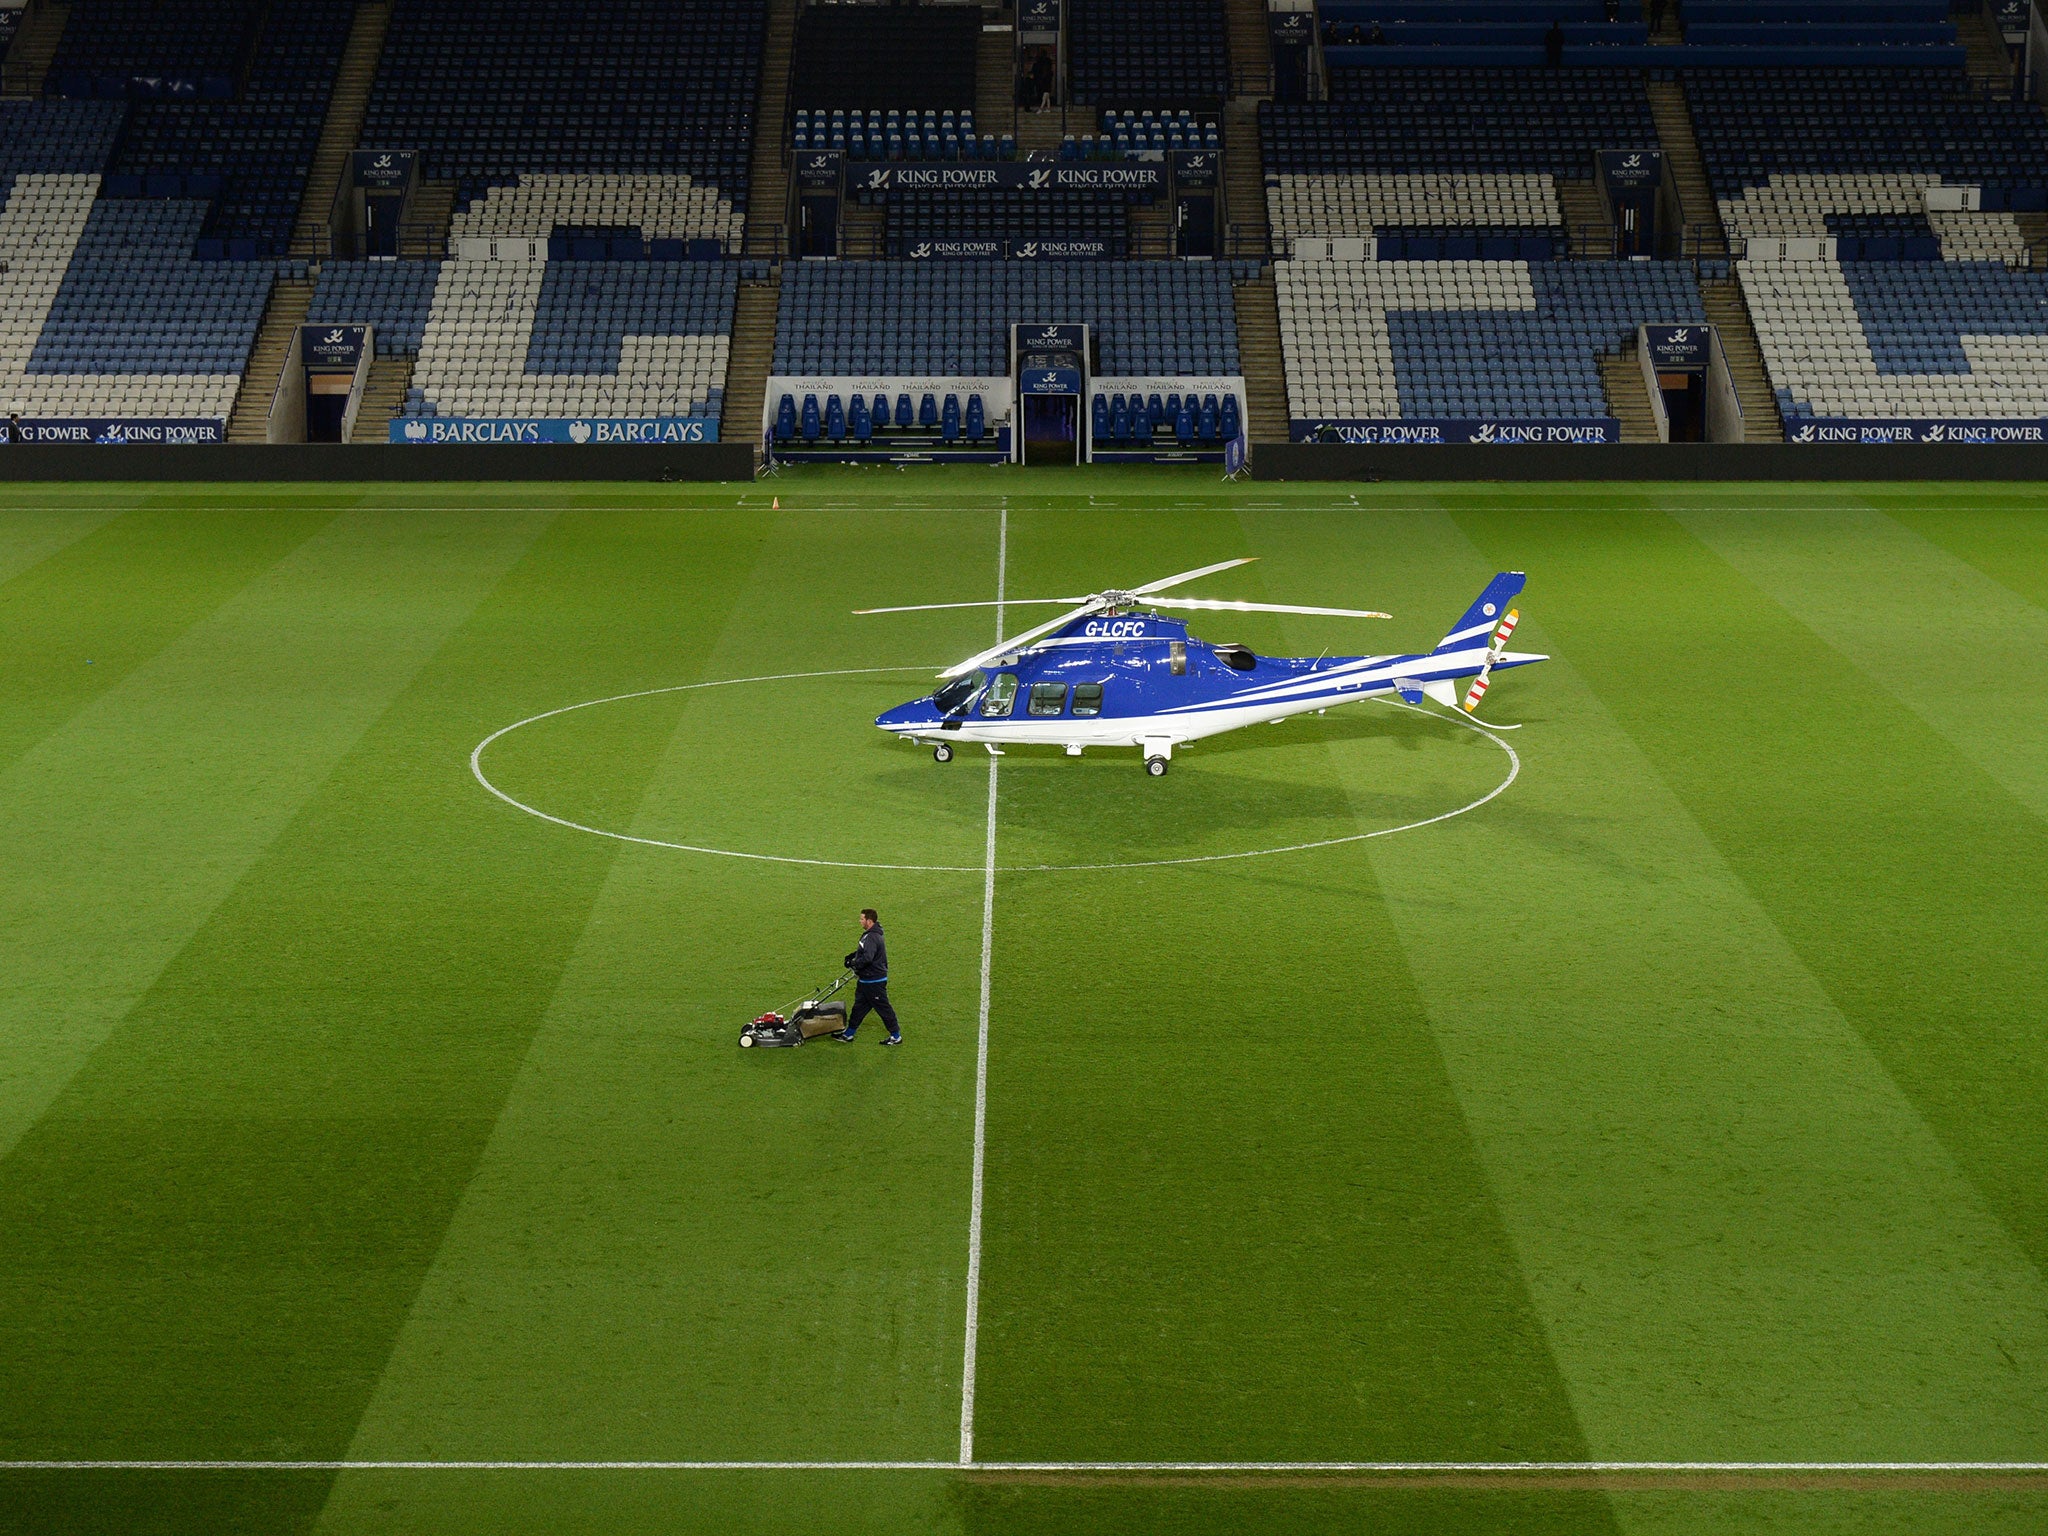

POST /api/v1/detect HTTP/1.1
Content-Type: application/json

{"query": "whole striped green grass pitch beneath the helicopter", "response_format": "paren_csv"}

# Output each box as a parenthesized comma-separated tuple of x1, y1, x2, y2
(0, 471, 2048, 1536)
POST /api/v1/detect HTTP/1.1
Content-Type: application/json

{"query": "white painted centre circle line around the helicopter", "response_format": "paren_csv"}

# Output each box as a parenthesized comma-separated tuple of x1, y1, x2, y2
(469, 666, 1522, 874)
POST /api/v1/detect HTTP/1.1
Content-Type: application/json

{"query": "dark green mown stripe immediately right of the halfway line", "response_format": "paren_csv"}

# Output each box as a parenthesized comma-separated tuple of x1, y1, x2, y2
(971, 512, 1608, 1530)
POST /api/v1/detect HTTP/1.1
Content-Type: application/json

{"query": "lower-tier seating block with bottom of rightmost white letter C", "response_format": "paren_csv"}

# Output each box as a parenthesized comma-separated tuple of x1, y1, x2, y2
(1737, 260, 2048, 423)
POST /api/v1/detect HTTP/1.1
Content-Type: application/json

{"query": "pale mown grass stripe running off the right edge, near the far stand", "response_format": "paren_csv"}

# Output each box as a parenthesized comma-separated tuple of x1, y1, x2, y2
(1671, 504, 2048, 819)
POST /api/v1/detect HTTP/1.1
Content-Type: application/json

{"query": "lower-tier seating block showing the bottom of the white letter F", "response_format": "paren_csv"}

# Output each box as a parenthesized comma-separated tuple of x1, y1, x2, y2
(1278, 260, 1706, 420)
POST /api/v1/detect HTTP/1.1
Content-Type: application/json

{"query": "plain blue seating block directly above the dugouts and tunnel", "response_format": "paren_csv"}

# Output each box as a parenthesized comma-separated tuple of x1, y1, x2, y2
(774, 262, 1239, 375)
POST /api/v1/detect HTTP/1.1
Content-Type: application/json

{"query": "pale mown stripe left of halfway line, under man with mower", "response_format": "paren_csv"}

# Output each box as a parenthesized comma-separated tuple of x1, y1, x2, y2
(328, 510, 995, 1482)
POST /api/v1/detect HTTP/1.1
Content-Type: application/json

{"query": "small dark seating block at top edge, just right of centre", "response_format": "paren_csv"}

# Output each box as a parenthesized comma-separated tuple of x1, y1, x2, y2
(1067, 0, 1231, 109)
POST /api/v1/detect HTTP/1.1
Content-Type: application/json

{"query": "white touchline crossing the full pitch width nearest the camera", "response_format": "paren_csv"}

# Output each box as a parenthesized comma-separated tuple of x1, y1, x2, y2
(0, 1458, 2048, 1477)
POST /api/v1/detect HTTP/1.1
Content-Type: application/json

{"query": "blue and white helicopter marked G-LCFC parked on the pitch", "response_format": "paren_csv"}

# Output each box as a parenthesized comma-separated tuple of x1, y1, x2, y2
(856, 559, 1548, 778)
